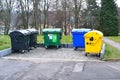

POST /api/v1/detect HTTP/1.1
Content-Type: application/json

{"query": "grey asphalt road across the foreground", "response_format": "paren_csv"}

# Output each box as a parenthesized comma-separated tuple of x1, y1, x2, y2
(0, 59, 120, 80)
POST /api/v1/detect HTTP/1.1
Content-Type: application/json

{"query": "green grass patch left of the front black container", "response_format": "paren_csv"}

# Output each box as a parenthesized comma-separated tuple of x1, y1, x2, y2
(0, 35, 11, 50)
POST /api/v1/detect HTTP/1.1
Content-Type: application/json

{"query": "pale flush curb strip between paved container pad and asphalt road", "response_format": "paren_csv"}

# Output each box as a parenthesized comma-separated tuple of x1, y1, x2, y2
(3, 57, 104, 63)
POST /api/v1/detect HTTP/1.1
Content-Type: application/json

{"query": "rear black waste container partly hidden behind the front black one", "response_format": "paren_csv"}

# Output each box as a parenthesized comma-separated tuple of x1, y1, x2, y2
(28, 28, 38, 48)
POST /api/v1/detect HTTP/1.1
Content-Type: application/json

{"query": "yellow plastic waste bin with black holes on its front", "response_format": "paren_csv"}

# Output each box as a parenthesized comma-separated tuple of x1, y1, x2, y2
(84, 30, 103, 57)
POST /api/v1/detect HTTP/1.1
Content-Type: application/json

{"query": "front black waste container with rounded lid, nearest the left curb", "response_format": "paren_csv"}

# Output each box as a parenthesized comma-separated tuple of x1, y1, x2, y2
(9, 30, 30, 53)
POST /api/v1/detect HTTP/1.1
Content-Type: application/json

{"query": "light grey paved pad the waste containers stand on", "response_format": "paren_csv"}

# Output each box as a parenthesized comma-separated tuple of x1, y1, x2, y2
(4, 47, 99, 61)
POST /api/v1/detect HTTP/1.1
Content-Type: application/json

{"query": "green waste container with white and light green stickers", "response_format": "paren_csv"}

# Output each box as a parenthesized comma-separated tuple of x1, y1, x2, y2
(43, 28, 62, 48)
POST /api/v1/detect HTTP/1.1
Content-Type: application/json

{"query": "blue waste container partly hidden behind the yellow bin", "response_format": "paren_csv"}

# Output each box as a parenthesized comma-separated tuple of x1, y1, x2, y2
(72, 28, 91, 50)
